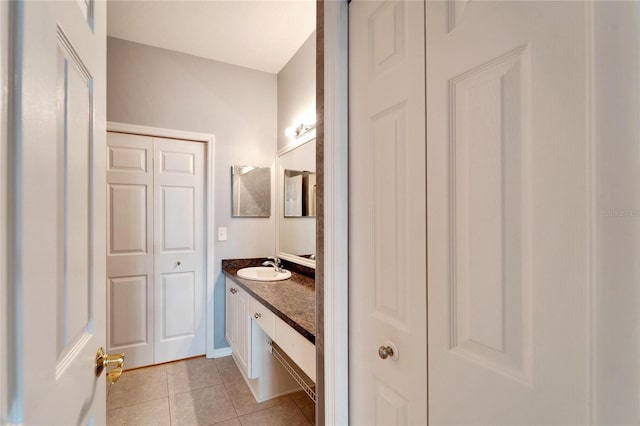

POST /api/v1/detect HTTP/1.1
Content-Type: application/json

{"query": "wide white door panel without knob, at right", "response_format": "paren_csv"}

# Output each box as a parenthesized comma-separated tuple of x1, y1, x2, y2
(426, 1, 596, 425)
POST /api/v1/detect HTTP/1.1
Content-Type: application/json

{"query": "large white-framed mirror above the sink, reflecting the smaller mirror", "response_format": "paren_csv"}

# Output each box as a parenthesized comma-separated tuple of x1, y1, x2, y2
(276, 132, 316, 268)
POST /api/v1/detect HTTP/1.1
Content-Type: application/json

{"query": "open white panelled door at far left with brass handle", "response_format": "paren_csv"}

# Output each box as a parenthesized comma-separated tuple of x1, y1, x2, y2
(6, 1, 106, 425)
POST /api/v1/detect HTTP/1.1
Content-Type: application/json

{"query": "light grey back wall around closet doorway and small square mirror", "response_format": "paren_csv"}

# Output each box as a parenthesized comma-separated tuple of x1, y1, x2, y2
(107, 37, 277, 348)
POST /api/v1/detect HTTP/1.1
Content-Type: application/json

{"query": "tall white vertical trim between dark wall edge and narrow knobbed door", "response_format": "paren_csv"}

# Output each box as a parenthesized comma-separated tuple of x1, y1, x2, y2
(324, 0, 349, 425)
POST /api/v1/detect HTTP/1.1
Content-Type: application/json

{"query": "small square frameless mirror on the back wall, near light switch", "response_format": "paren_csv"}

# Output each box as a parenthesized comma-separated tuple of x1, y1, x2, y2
(231, 166, 271, 217)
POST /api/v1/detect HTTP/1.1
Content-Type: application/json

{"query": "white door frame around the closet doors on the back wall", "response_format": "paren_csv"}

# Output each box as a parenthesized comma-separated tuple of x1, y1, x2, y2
(107, 121, 216, 358)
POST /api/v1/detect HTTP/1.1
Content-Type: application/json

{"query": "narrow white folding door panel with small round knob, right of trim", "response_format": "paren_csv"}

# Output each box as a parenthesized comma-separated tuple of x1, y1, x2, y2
(349, 1, 427, 425)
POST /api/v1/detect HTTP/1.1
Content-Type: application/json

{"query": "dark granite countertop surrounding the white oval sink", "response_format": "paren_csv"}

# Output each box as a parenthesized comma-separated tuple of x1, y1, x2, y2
(222, 259, 316, 345)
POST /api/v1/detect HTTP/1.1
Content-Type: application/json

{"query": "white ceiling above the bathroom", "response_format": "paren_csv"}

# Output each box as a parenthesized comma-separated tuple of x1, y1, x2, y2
(107, 0, 316, 74)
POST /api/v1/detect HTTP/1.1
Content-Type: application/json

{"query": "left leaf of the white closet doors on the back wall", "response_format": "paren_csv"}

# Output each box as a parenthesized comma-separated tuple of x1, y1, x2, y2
(107, 132, 154, 368)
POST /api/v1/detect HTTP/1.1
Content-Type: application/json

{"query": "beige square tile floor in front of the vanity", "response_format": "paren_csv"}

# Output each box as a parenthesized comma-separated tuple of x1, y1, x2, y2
(107, 357, 315, 426)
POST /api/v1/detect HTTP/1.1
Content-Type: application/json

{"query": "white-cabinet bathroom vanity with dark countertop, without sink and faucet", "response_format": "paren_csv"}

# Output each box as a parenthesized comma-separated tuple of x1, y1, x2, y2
(222, 259, 316, 402)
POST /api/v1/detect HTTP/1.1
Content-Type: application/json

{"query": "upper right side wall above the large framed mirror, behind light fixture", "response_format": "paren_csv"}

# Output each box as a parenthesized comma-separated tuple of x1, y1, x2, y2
(278, 31, 316, 149)
